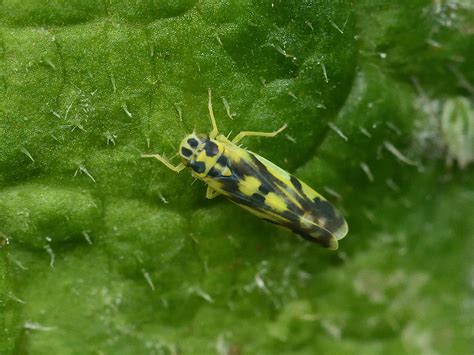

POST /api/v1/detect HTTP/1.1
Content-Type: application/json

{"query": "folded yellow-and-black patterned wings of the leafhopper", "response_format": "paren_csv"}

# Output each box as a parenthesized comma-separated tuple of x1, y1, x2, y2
(203, 144, 348, 249)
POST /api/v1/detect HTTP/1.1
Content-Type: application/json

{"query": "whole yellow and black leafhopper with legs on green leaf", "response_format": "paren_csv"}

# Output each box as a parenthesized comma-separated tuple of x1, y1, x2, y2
(142, 89, 348, 250)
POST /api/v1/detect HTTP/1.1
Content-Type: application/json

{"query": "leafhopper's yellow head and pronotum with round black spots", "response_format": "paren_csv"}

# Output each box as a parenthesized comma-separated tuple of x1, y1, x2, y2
(179, 133, 224, 178)
